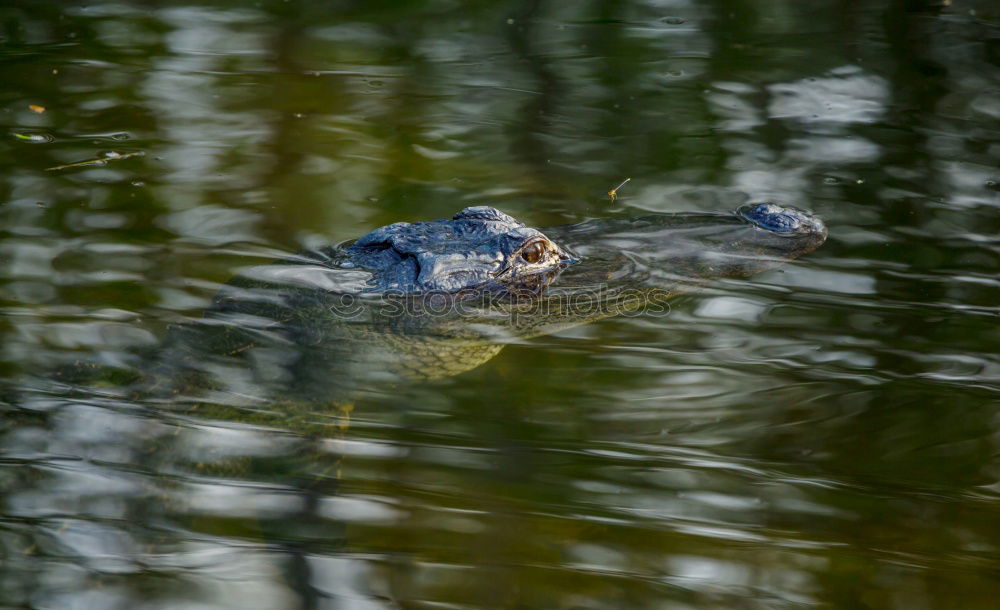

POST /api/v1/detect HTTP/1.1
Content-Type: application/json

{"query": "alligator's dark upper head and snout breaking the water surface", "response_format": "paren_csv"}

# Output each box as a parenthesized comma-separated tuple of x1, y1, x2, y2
(339, 203, 826, 298)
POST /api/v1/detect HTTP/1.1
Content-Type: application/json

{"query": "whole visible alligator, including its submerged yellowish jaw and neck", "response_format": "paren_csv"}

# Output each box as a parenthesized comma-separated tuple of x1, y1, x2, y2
(161, 203, 826, 401)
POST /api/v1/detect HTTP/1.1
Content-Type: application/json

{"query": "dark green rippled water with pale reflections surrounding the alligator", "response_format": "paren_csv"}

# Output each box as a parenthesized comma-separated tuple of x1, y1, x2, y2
(0, 0, 1000, 610)
